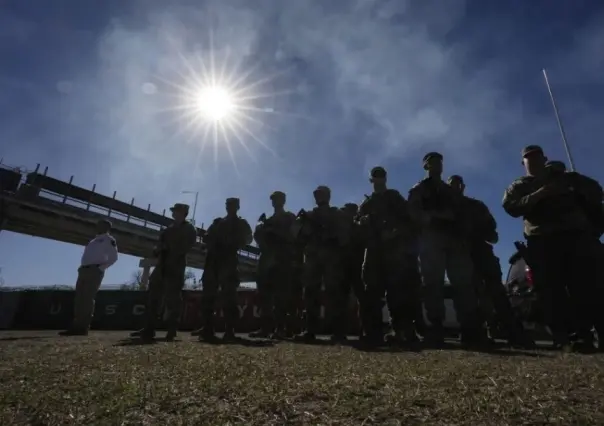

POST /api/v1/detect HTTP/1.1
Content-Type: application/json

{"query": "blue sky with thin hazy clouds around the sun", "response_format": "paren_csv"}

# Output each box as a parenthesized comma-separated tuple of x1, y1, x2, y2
(0, 0, 604, 285)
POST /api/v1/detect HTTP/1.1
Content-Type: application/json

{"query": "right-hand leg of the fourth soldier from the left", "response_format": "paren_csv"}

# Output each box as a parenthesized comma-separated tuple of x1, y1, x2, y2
(323, 251, 350, 340)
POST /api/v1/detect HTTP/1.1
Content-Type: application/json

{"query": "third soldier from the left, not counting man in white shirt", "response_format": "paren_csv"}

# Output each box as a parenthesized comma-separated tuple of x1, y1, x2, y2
(250, 191, 296, 339)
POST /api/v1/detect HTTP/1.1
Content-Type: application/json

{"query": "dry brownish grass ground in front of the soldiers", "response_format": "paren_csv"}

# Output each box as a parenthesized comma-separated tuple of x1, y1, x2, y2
(0, 332, 604, 426)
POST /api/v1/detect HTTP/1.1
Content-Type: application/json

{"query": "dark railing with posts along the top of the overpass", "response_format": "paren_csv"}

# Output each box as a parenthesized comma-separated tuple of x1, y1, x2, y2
(0, 165, 259, 262)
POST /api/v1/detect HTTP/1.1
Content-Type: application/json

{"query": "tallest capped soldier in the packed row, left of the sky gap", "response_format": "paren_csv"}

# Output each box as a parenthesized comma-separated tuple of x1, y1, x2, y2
(409, 152, 483, 345)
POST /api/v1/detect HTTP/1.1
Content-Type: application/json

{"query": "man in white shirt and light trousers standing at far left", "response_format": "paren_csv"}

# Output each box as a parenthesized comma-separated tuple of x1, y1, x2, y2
(60, 220, 118, 336)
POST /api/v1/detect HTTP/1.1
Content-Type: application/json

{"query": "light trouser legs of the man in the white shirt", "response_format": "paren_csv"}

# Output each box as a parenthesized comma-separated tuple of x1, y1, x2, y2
(72, 267, 104, 334)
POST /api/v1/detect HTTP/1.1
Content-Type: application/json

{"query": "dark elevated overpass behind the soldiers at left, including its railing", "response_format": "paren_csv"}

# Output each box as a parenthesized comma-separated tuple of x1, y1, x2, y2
(0, 165, 259, 282)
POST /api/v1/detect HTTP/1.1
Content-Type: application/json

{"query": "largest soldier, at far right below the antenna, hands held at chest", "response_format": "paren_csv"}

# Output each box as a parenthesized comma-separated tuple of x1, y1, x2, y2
(503, 145, 604, 351)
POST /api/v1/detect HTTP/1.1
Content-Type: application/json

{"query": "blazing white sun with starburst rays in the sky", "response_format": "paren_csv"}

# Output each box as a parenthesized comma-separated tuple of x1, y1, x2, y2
(150, 32, 293, 173)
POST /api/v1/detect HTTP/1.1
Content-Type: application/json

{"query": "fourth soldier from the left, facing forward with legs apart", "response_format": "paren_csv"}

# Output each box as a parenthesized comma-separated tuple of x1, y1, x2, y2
(294, 186, 348, 342)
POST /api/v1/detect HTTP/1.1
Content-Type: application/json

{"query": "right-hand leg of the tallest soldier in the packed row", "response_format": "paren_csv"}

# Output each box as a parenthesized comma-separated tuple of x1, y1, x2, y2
(446, 239, 486, 342)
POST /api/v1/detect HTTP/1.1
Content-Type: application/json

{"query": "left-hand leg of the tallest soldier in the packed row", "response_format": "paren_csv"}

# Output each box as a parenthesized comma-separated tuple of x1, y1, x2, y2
(419, 231, 450, 330)
